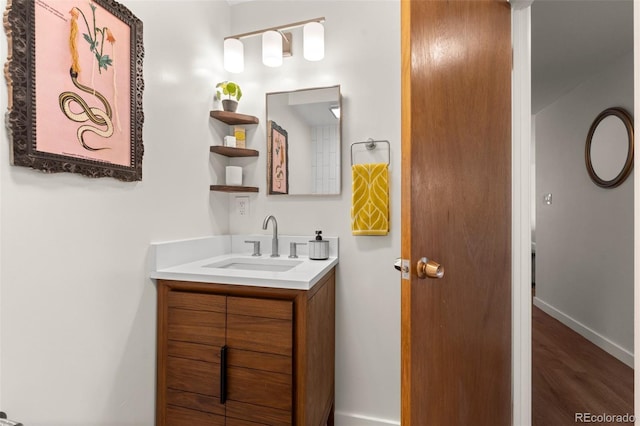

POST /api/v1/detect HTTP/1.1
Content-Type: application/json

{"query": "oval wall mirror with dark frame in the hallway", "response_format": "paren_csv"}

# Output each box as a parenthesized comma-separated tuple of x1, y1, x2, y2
(584, 108, 633, 188)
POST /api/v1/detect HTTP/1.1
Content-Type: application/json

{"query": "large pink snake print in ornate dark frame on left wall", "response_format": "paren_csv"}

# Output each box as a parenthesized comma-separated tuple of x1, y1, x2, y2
(5, 0, 144, 182)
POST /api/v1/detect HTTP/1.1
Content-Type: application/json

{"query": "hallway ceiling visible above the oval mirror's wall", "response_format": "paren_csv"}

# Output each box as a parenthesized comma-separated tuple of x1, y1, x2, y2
(531, 0, 633, 114)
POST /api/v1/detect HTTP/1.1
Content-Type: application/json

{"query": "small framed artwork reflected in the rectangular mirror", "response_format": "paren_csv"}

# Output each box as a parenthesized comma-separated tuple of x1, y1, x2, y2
(267, 120, 289, 194)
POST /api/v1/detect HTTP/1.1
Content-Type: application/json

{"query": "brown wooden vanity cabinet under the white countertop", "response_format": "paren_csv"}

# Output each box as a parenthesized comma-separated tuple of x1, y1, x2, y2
(156, 270, 335, 426)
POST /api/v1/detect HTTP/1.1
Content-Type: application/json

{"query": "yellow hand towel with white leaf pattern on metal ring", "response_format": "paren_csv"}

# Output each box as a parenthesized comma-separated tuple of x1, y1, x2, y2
(351, 163, 389, 235)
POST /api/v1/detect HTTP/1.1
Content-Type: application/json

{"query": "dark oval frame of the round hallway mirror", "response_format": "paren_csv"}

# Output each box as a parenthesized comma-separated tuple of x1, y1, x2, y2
(584, 107, 634, 188)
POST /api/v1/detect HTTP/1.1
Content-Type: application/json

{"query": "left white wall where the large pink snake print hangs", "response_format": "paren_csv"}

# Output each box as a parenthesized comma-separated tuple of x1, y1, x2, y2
(0, 0, 232, 426)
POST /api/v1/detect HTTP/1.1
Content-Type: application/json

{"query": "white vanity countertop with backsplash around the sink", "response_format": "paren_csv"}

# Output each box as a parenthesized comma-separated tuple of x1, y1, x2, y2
(149, 234, 338, 290)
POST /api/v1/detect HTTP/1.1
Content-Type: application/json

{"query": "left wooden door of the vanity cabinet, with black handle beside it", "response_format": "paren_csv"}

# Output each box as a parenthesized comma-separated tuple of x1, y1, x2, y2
(166, 291, 226, 420)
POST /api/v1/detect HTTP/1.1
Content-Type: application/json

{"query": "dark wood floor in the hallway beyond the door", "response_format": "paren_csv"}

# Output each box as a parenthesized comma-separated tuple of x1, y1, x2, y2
(532, 306, 633, 426)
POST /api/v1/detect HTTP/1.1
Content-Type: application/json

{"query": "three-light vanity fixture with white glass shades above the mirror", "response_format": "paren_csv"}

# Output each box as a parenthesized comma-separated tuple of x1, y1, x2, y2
(224, 17, 325, 73)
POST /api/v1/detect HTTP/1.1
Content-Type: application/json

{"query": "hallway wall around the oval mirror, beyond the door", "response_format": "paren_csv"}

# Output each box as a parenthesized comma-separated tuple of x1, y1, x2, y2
(535, 52, 634, 363)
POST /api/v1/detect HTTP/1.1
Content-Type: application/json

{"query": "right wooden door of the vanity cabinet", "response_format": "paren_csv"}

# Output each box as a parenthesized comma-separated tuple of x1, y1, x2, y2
(226, 297, 293, 426)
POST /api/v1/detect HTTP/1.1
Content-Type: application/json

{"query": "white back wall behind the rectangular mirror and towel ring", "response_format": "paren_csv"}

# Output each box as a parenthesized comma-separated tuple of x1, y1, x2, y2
(229, 1, 400, 426)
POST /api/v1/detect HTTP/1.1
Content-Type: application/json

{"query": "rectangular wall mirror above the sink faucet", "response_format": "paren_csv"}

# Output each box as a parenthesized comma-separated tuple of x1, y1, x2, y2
(267, 86, 342, 195)
